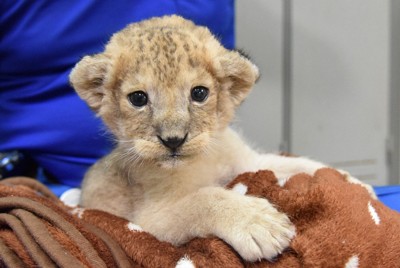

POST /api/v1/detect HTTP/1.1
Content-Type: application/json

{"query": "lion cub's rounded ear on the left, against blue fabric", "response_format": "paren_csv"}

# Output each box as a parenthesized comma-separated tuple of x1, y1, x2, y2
(69, 54, 109, 113)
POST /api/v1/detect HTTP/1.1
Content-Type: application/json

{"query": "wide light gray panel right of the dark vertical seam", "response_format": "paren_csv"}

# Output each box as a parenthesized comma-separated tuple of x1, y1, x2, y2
(292, 0, 390, 184)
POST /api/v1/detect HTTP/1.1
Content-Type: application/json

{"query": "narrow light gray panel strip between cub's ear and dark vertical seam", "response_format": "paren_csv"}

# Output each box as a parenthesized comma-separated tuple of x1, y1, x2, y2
(236, 0, 283, 151)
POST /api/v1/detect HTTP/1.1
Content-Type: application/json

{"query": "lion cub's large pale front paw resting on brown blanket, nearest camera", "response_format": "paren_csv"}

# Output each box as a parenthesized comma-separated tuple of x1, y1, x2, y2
(220, 196, 296, 261)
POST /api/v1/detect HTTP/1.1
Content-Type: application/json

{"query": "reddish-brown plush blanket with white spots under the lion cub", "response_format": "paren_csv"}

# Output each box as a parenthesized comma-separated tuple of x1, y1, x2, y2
(0, 169, 400, 268)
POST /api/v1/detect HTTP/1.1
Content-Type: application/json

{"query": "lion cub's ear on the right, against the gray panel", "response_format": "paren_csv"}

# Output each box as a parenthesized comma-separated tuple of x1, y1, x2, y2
(219, 51, 260, 106)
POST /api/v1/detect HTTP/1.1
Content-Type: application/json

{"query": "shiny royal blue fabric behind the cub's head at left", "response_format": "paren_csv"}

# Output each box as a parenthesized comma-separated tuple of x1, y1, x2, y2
(0, 0, 234, 186)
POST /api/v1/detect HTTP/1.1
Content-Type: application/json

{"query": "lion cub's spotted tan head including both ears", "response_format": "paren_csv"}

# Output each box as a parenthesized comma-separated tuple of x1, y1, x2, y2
(70, 16, 258, 166)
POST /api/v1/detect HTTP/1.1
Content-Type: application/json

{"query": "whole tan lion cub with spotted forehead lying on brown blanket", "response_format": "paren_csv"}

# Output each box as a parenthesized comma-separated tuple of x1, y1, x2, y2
(70, 16, 372, 261)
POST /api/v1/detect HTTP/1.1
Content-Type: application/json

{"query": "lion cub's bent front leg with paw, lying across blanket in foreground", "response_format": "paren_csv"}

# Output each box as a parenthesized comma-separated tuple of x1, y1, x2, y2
(137, 187, 295, 261)
